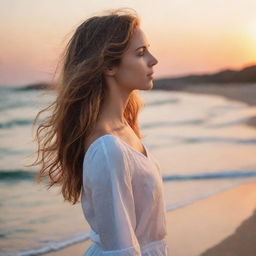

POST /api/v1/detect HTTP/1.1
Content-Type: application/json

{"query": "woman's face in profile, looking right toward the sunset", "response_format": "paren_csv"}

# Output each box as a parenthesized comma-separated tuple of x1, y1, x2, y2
(112, 27, 158, 91)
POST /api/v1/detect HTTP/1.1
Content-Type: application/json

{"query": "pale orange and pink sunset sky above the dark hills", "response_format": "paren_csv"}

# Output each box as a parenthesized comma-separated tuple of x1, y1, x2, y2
(0, 0, 256, 86)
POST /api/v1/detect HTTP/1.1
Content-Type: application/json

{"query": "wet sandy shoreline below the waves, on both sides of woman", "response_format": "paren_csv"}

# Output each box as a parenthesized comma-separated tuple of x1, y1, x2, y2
(47, 179, 256, 256)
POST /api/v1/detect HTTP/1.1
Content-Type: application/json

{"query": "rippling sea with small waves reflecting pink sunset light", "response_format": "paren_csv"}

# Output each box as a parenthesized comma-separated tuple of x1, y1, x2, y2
(0, 87, 256, 256)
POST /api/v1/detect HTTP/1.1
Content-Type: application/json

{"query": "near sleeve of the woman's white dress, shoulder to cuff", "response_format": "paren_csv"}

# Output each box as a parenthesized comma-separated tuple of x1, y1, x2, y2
(84, 140, 141, 256)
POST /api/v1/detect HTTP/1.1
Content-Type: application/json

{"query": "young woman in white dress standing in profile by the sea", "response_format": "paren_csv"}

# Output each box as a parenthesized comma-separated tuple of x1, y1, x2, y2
(31, 9, 168, 256)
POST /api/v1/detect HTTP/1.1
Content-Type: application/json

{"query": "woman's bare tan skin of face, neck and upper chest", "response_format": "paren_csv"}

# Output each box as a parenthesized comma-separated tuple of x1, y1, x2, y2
(85, 27, 158, 155)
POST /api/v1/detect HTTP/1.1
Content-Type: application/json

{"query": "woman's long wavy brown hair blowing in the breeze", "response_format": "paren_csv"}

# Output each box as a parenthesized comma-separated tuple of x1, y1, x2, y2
(30, 8, 144, 204)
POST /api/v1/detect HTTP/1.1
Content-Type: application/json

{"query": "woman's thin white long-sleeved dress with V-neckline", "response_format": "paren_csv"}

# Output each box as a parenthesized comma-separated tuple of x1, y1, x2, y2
(81, 134, 169, 256)
